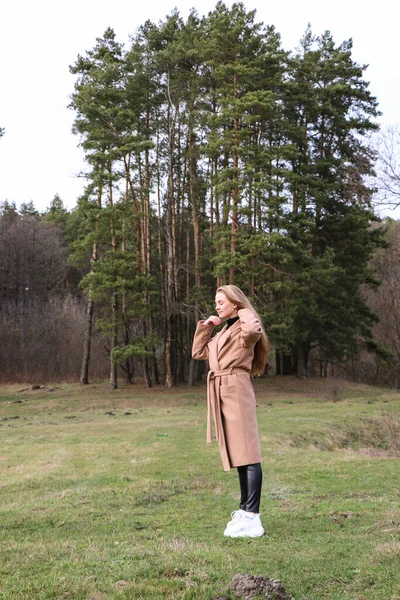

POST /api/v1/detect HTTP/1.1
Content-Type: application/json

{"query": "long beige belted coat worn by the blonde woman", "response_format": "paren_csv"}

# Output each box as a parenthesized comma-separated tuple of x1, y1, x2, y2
(192, 308, 262, 471)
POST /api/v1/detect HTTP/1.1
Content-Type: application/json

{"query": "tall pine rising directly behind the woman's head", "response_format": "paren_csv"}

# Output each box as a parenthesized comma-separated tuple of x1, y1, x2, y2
(206, 2, 284, 283)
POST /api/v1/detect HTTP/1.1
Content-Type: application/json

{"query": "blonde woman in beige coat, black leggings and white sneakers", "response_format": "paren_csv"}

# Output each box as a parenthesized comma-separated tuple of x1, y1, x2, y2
(192, 285, 268, 537)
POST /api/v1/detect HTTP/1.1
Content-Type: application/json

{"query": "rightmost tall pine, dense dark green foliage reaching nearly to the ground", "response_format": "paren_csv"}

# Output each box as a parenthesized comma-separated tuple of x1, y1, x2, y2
(272, 29, 382, 376)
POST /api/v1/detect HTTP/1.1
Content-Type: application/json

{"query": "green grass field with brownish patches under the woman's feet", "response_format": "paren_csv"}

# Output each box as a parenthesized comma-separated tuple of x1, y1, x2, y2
(0, 378, 400, 600)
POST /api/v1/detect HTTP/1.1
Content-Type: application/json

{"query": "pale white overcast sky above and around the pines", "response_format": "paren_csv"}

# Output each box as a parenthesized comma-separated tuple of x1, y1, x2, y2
(0, 0, 400, 218)
